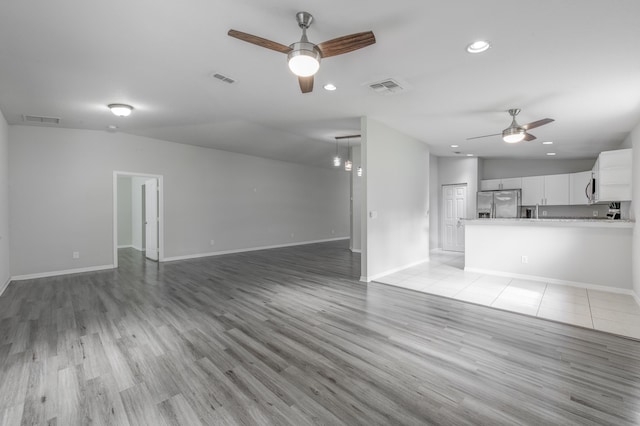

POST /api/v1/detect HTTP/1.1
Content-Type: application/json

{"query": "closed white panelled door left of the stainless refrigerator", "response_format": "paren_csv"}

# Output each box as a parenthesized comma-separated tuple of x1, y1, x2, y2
(442, 184, 467, 252)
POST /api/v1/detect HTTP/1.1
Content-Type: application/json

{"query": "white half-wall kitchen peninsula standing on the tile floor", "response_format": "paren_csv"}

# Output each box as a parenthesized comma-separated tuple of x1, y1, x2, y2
(465, 219, 634, 293)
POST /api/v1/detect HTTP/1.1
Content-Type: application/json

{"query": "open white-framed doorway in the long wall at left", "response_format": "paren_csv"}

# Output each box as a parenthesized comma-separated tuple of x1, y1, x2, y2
(113, 172, 164, 268)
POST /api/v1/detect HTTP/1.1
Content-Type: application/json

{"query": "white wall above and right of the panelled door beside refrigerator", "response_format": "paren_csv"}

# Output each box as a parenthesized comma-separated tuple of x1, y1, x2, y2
(437, 157, 478, 221)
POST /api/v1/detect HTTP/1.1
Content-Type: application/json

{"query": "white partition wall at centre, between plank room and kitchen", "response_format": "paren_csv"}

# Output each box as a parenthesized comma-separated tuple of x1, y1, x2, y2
(361, 117, 429, 281)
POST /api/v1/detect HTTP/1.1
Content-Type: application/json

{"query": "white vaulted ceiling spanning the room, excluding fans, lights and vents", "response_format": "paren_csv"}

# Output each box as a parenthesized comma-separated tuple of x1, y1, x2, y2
(0, 0, 640, 167)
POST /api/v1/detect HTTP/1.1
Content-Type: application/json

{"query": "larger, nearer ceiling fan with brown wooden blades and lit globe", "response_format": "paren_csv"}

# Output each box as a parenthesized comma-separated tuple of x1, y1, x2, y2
(227, 12, 376, 93)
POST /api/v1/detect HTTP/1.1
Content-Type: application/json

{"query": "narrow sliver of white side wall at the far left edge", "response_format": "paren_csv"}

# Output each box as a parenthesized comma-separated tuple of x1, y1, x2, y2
(0, 112, 11, 294)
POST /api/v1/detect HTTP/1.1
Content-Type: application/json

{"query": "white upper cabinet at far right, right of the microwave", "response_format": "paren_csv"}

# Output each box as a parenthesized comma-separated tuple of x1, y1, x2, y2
(593, 149, 632, 202)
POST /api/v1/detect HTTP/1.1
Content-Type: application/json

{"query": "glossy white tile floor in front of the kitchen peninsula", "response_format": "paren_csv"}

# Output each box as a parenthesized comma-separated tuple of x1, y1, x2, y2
(376, 251, 640, 339)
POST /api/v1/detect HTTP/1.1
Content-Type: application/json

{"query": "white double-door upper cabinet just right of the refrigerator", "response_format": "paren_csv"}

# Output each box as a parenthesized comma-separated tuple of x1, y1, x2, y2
(522, 174, 569, 206)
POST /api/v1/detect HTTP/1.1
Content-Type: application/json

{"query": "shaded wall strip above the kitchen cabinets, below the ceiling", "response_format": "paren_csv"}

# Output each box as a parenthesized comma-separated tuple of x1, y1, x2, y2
(480, 158, 596, 179)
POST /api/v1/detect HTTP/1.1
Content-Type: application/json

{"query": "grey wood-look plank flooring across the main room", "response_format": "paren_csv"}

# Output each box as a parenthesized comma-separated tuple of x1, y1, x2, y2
(0, 242, 640, 426)
